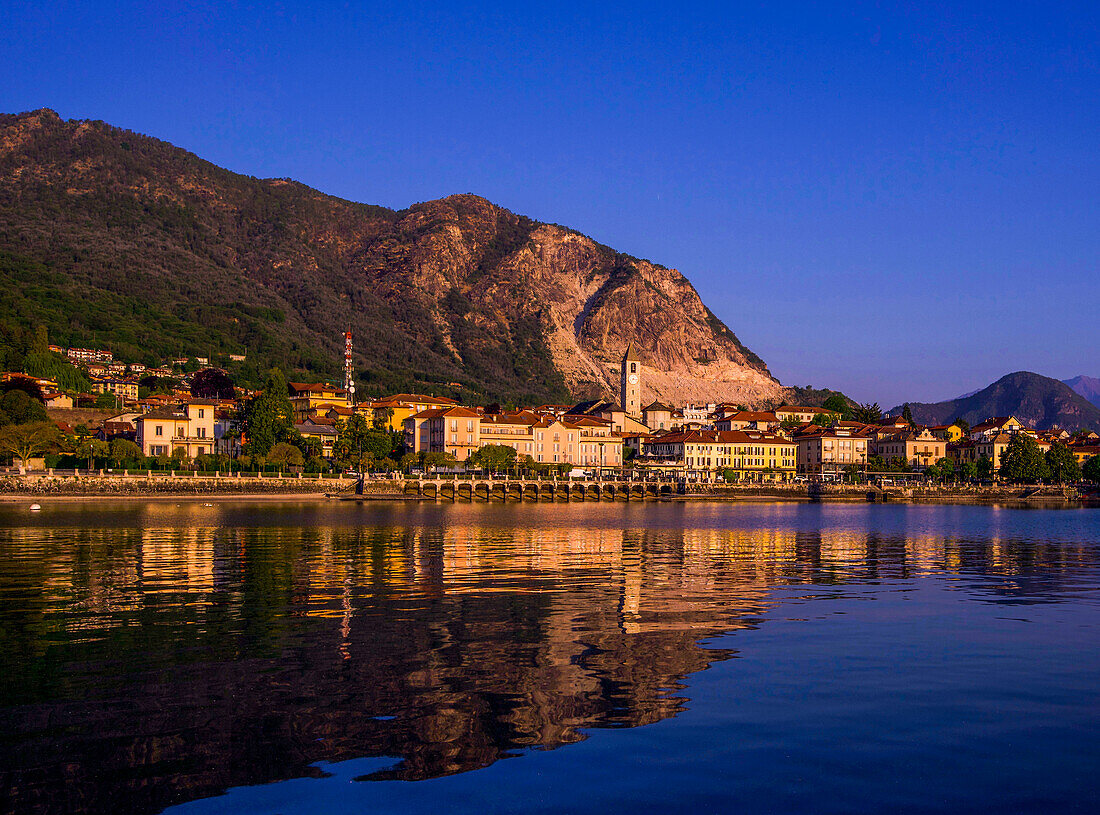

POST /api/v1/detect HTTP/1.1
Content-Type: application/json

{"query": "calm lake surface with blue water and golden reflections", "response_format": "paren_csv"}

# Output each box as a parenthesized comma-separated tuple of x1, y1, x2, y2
(0, 502, 1100, 815)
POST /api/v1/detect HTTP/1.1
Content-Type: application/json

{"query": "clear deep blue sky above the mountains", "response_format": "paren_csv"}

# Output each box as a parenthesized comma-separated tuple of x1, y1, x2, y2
(0, 2, 1100, 407)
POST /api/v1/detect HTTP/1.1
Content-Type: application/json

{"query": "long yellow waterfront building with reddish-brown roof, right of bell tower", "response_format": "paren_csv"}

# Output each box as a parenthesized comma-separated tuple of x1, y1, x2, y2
(640, 430, 798, 482)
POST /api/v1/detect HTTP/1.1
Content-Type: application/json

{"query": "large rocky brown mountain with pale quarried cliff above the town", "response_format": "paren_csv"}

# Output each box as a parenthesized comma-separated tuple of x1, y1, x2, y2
(0, 110, 787, 404)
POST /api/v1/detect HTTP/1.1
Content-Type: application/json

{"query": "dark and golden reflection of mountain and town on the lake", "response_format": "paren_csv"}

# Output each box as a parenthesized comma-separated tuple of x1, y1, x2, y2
(0, 508, 1084, 812)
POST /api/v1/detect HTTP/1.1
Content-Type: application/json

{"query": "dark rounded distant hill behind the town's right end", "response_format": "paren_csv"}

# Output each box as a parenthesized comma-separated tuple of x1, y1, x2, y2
(889, 371, 1100, 431)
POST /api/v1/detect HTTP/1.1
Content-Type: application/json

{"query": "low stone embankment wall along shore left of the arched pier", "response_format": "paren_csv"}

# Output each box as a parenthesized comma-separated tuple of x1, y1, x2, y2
(0, 473, 400, 497)
